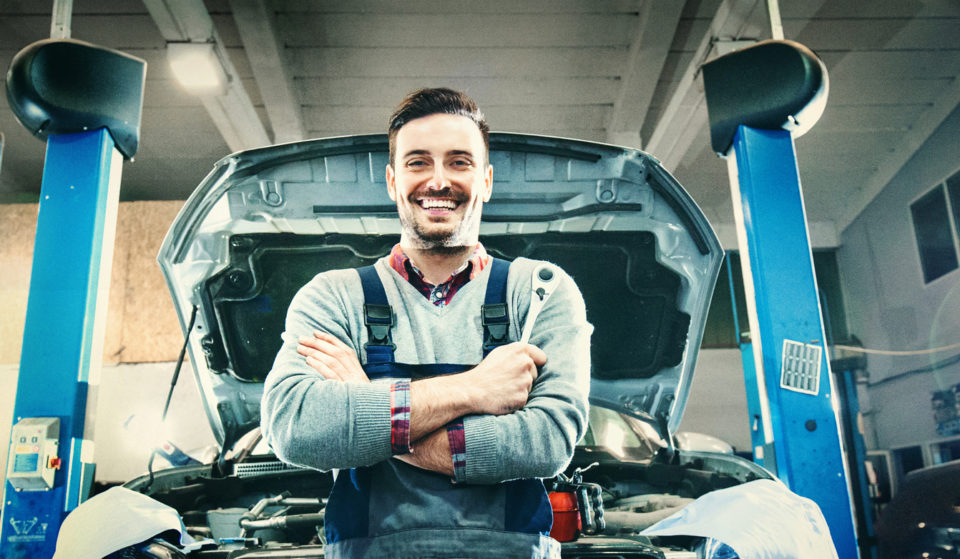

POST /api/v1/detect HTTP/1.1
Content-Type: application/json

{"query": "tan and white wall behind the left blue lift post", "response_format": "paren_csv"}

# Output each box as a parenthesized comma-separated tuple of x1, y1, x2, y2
(0, 202, 197, 490)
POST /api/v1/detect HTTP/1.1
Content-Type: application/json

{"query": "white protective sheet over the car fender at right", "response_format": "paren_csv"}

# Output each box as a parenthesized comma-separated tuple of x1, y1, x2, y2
(642, 480, 837, 559)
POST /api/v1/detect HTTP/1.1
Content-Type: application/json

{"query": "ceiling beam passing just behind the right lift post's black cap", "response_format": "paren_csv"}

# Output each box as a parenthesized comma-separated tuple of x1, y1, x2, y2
(644, 0, 765, 172)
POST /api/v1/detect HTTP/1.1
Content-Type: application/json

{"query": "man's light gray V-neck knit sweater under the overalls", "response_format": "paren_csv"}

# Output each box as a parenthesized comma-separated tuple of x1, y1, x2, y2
(261, 258, 593, 556)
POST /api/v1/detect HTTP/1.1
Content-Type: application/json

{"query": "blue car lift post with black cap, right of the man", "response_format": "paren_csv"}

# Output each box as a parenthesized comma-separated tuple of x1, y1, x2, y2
(703, 41, 859, 559)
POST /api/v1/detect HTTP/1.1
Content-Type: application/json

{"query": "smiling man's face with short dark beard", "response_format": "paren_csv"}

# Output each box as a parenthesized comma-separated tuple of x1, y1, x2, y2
(387, 114, 493, 250)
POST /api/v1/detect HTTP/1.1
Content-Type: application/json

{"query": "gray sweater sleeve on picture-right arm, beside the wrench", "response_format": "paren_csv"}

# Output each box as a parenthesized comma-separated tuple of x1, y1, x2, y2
(455, 269, 593, 483)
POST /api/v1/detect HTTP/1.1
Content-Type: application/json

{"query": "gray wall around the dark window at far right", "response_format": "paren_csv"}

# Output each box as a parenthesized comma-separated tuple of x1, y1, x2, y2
(837, 103, 960, 448)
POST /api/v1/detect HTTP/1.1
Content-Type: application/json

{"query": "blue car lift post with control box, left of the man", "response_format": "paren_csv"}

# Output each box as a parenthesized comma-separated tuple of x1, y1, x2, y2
(0, 40, 146, 559)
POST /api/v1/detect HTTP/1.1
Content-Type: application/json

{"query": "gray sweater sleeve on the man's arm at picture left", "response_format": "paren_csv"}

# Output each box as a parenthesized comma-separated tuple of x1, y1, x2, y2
(260, 270, 402, 470)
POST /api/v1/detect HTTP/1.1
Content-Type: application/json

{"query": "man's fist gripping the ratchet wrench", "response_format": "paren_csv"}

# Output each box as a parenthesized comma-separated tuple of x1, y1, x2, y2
(464, 342, 547, 415)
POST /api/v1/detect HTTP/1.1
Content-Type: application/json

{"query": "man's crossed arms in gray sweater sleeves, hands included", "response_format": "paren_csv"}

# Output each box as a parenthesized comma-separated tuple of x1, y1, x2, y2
(261, 259, 592, 483)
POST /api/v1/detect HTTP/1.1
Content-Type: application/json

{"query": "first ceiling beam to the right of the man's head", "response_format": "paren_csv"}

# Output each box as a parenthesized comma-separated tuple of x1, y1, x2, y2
(607, 0, 683, 148)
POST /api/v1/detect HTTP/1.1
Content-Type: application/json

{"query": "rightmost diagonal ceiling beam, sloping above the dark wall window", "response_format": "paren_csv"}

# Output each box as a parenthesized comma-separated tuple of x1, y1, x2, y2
(837, 76, 960, 231)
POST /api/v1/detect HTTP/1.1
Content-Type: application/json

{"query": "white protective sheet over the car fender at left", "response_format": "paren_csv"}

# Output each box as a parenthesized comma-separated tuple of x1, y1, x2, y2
(53, 487, 195, 559)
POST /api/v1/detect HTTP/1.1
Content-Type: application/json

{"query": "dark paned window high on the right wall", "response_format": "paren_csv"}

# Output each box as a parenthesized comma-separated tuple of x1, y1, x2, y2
(910, 168, 960, 283)
